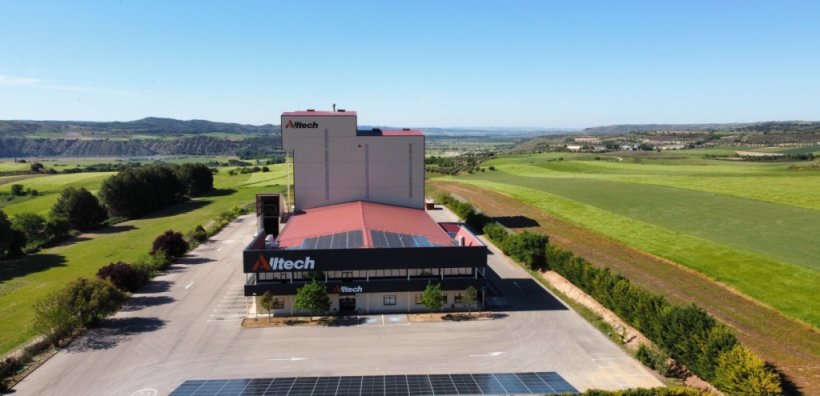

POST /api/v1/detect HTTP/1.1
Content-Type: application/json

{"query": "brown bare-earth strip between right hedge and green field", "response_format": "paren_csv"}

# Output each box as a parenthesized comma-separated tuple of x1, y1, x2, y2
(430, 181, 820, 395)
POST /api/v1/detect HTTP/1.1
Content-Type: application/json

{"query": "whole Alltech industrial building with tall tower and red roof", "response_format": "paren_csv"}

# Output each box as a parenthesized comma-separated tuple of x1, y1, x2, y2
(243, 110, 487, 314)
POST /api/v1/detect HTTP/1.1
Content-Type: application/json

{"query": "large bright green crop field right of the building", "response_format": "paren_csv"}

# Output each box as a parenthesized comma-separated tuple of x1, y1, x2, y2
(445, 150, 820, 327)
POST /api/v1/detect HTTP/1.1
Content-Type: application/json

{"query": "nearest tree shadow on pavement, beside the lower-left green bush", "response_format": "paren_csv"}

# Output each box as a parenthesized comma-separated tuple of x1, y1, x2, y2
(65, 318, 165, 353)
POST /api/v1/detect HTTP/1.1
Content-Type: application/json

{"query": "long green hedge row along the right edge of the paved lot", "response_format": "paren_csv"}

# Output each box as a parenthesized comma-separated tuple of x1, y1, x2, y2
(438, 191, 782, 395)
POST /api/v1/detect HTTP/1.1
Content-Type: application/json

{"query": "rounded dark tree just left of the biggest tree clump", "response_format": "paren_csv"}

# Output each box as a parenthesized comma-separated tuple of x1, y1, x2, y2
(51, 187, 108, 231)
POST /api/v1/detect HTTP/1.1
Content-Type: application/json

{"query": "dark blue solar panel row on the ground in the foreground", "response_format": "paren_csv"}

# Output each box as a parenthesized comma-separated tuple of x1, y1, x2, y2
(171, 372, 578, 396)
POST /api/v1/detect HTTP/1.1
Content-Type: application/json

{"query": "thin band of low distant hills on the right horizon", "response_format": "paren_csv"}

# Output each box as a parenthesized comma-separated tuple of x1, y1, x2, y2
(580, 121, 820, 135)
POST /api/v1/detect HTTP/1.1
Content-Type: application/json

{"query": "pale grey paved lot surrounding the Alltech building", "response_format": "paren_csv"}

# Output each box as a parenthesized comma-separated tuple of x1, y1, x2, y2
(15, 216, 661, 395)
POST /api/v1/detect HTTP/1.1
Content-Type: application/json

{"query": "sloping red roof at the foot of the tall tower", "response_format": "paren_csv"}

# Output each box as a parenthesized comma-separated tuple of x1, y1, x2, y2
(277, 201, 453, 249)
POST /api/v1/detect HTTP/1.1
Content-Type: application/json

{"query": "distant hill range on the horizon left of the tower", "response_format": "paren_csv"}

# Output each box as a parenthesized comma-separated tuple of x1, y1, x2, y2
(0, 117, 280, 158)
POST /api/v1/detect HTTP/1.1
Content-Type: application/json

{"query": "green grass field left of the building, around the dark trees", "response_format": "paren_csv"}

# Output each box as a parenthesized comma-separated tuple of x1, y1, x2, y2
(0, 165, 285, 354)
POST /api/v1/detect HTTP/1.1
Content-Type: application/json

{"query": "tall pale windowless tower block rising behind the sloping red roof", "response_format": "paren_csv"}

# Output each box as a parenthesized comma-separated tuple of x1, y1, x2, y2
(282, 113, 424, 210)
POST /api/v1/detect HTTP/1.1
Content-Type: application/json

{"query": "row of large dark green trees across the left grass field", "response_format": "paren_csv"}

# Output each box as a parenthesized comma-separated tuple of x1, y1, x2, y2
(0, 164, 213, 259)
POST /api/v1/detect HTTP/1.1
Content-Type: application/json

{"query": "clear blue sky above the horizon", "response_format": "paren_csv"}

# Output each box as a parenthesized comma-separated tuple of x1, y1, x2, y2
(0, 0, 820, 127)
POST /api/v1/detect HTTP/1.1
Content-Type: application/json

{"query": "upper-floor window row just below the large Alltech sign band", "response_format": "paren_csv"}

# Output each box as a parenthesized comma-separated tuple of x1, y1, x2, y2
(257, 267, 473, 281)
